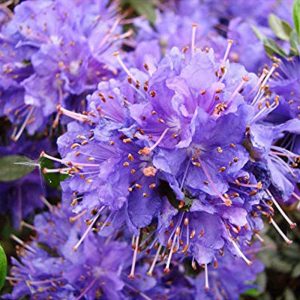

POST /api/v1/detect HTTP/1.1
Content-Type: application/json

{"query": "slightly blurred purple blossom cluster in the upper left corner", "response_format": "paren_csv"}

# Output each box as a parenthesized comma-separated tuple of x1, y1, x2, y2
(0, 0, 122, 140)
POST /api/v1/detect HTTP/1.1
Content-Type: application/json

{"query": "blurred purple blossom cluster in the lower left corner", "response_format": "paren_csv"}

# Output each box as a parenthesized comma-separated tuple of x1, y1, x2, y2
(7, 207, 130, 299)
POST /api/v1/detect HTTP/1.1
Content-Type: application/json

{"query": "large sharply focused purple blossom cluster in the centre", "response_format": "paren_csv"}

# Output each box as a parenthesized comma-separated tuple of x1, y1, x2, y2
(43, 32, 300, 286)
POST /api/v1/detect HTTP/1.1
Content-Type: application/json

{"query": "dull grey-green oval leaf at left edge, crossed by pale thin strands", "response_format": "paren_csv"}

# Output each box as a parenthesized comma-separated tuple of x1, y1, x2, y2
(0, 155, 35, 182)
